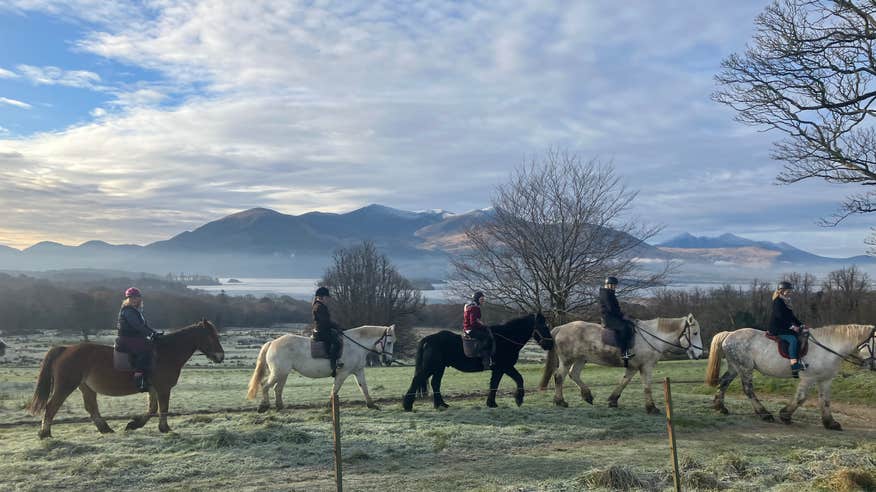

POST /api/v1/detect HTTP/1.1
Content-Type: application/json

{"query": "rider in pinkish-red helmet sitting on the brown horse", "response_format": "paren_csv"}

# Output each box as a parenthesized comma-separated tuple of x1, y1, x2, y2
(118, 287, 161, 391)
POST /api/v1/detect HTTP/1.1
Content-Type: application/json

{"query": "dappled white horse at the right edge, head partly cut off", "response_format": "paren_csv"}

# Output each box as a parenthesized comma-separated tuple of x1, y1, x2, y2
(706, 325, 876, 430)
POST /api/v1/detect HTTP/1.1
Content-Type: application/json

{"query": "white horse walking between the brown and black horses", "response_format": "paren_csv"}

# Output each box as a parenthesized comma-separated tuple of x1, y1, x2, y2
(246, 325, 395, 412)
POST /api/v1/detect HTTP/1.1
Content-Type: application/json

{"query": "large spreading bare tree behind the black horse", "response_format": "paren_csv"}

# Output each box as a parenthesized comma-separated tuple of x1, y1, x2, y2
(451, 151, 668, 321)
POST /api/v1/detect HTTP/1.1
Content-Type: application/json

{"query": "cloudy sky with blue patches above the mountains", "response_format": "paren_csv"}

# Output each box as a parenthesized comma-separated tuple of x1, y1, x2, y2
(0, 0, 871, 256)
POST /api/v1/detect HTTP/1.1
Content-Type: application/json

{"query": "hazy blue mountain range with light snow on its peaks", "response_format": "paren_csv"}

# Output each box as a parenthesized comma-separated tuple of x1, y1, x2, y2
(0, 204, 876, 278)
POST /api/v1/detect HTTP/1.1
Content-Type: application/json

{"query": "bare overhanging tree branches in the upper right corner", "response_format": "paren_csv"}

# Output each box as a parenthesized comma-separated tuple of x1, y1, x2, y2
(714, 0, 876, 244)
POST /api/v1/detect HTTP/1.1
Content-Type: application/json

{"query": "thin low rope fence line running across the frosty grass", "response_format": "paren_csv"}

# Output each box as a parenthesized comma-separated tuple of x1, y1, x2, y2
(0, 380, 703, 429)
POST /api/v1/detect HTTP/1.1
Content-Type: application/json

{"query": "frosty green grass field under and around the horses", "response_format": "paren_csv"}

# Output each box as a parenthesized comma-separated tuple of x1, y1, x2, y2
(0, 332, 876, 492)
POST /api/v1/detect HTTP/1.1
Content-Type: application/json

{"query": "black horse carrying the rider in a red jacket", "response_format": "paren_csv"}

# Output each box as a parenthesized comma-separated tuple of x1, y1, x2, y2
(402, 313, 554, 412)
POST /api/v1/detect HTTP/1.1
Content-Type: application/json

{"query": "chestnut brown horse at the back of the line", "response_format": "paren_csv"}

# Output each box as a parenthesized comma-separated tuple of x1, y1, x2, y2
(27, 319, 225, 439)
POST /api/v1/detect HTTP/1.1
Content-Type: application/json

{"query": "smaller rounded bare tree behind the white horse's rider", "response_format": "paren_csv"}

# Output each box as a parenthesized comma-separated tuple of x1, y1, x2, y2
(321, 241, 425, 345)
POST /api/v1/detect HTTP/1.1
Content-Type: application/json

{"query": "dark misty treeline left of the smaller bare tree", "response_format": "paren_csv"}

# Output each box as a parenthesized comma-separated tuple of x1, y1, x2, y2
(0, 274, 311, 337)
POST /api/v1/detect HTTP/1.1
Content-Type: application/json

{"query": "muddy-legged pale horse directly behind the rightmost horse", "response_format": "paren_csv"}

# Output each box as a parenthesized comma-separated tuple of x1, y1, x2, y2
(539, 314, 703, 414)
